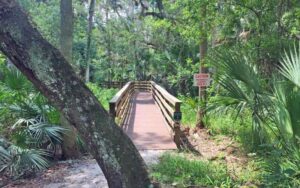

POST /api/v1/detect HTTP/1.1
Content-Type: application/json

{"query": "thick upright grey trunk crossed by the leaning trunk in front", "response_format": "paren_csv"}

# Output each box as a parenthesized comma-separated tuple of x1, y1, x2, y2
(60, 0, 80, 158)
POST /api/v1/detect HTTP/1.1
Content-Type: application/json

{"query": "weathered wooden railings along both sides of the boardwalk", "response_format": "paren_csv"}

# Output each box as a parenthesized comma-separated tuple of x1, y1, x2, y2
(109, 81, 181, 132)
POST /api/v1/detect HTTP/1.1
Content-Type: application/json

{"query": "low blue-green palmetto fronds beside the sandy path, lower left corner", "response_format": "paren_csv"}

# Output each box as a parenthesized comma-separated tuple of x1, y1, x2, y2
(0, 117, 64, 176)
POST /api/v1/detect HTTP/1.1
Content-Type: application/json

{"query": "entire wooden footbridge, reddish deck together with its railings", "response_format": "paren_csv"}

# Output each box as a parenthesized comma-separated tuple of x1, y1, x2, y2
(110, 81, 181, 150)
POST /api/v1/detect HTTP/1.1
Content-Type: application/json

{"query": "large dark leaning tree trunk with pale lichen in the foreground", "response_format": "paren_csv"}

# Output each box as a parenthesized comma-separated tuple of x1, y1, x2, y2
(0, 0, 150, 188)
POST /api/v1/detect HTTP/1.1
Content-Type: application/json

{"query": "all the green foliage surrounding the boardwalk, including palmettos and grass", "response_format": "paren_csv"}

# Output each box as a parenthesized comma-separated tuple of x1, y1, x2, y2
(0, 0, 300, 187)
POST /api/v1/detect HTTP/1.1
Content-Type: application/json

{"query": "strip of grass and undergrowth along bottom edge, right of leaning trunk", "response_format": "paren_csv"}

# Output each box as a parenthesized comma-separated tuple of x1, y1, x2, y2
(150, 152, 292, 188)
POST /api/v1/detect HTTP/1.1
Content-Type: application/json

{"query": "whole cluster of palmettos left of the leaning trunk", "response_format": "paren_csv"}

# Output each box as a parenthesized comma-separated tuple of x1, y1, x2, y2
(0, 67, 65, 177)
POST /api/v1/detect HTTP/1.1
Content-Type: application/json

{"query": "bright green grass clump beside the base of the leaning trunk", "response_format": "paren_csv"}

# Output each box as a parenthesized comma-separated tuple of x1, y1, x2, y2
(151, 153, 233, 187)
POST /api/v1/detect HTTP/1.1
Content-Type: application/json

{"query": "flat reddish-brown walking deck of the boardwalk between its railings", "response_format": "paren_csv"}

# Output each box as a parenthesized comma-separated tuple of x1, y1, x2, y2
(122, 92, 176, 150)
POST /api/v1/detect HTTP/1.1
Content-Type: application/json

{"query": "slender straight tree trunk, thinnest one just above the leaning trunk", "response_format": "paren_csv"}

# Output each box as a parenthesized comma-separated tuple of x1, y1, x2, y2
(85, 0, 95, 83)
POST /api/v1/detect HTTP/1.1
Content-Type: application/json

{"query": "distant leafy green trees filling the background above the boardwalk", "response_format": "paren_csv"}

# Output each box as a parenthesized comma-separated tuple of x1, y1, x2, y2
(14, 0, 300, 92)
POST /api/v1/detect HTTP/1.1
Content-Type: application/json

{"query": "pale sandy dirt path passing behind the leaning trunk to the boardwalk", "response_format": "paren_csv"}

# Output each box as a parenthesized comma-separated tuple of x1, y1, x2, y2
(5, 150, 165, 188)
